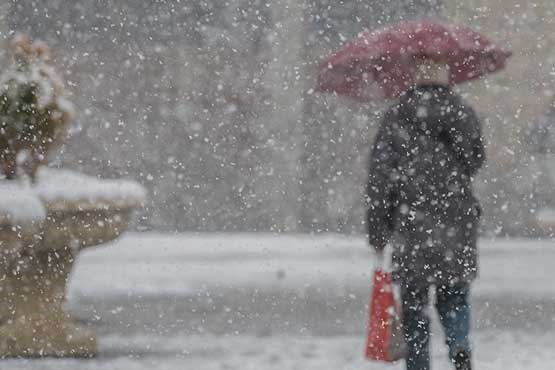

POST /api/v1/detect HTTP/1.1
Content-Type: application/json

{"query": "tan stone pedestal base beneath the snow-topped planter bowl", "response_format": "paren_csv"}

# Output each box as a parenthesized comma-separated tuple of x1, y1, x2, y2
(0, 246, 97, 357)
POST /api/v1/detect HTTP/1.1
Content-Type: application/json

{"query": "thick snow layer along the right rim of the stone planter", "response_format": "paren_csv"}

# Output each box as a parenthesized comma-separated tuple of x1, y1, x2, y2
(34, 167, 146, 209)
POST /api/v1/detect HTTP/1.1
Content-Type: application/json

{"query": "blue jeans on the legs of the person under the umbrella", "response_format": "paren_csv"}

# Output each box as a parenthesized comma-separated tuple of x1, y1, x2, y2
(401, 284, 470, 370)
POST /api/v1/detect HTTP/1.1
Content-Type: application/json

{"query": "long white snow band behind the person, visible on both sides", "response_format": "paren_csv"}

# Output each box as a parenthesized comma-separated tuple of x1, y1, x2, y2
(70, 233, 555, 297)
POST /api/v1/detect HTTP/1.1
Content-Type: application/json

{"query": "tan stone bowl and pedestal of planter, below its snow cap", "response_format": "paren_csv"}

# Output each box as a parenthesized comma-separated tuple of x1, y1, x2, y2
(0, 168, 146, 357)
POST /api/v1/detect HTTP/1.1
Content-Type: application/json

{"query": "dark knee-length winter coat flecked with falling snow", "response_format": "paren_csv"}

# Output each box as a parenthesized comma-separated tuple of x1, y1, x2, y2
(367, 85, 485, 285)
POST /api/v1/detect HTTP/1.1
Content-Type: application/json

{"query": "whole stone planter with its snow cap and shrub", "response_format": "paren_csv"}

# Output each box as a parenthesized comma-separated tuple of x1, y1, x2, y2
(0, 36, 145, 357)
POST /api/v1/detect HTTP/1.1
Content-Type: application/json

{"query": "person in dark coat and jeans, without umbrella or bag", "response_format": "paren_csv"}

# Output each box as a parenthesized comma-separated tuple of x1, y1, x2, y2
(366, 61, 485, 370)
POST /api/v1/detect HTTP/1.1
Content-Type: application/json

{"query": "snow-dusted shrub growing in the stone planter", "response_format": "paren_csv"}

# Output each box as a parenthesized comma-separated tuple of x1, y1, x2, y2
(0, 35, 73, 180)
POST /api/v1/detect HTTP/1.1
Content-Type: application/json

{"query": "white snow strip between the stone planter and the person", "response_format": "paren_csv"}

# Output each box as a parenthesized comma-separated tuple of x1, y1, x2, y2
(70, 234, 372, 295)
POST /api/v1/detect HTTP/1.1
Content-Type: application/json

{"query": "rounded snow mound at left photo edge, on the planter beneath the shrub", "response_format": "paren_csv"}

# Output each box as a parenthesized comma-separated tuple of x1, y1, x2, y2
(0, 181, 46, 224)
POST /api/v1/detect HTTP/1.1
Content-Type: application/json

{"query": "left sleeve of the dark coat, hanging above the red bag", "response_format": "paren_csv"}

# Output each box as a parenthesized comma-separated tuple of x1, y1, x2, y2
(366, 119, 397, 249)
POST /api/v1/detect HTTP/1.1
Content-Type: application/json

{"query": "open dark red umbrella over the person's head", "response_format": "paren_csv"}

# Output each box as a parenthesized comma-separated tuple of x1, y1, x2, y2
(317, 21, 511, 100)
